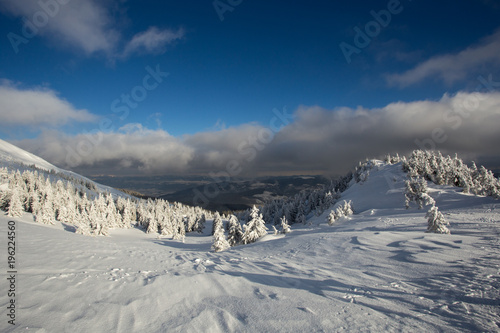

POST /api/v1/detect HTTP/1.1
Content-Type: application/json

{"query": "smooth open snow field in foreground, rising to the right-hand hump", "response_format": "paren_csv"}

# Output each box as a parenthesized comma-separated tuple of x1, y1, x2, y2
(0, 163, 500, 332)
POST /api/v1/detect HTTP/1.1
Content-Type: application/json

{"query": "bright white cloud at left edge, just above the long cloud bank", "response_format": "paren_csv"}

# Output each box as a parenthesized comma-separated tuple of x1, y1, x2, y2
(0, 81, 97, 127)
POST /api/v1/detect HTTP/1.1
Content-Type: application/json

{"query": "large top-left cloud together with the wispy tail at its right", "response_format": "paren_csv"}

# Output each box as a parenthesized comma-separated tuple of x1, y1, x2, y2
(0, 0, 184, 59)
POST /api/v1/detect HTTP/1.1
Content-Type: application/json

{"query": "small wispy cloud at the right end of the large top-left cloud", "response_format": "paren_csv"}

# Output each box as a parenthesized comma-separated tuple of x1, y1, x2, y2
(123, 27, 185, 56)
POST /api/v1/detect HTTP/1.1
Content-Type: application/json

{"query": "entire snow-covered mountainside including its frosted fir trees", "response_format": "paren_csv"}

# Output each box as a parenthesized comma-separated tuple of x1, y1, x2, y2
(0, 142, 500, 332)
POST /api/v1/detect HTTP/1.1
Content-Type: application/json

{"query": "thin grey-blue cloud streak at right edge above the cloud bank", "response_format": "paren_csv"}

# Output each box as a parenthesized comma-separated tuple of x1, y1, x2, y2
(387, 30, 500, 87)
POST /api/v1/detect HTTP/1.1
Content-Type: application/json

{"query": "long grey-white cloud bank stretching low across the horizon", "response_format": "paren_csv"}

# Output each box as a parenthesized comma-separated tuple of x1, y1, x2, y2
(15, 92, 500, 176)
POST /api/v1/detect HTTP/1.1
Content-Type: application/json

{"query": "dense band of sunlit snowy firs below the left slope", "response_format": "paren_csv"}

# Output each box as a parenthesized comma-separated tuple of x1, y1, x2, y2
(0, 168, 213, 240)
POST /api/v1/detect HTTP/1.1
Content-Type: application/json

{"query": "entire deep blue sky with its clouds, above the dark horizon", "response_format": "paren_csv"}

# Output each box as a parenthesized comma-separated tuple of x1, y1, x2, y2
(0, 0, 500, 173)
